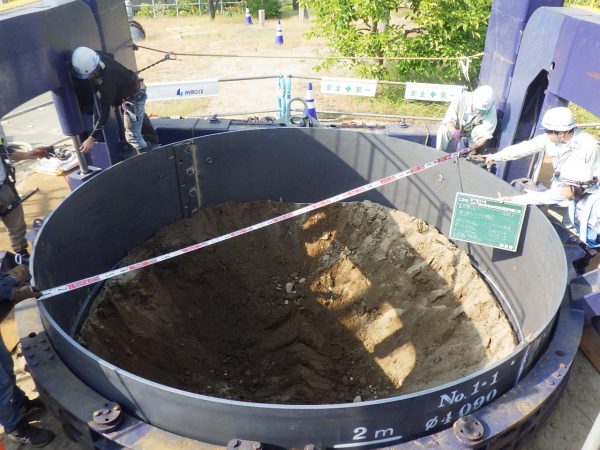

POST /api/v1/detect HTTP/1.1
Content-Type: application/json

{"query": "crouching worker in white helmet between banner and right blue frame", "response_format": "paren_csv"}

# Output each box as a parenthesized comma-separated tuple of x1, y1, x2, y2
(435, 86, 498, 154)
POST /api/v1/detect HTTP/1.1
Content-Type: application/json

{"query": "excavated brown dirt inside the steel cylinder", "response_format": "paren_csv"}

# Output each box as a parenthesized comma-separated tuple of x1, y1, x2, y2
(80, 202, 516, 404)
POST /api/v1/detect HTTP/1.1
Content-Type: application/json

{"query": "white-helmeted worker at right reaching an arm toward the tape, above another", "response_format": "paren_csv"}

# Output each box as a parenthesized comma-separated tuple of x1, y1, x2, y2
(482, 106, 600, 205)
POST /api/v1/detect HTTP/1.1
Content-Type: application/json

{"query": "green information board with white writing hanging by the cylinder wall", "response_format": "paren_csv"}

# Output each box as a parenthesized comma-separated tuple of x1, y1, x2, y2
(450, 192, 526, 252)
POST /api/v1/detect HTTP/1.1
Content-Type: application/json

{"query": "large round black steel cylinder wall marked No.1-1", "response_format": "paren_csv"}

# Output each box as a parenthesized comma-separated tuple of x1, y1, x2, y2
(33, 128, 567, 447)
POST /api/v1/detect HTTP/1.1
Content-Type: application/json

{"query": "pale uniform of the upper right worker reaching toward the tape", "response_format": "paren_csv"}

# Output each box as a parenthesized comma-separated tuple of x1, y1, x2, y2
(494, 128, 600, 205)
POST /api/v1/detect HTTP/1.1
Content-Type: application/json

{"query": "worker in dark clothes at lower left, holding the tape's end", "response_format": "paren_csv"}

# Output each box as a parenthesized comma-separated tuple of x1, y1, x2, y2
(0, 264, 54, 447)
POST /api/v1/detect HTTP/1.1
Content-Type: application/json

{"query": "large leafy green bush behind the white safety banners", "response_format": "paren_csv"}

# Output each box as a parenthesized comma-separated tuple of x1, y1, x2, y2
(301, 0, 492, 82)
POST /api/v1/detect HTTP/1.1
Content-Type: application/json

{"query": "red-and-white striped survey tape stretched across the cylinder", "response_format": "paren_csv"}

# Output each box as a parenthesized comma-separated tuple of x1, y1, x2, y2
(39, 149, 469, 300)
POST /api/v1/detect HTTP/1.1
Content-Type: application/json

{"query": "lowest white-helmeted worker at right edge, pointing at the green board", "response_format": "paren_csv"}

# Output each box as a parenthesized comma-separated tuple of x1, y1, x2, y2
(503, 158, 600, 248)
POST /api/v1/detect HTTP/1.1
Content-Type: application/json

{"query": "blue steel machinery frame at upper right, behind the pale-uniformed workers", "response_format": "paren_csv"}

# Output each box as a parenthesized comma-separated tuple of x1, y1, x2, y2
(480, 0, 600, 181)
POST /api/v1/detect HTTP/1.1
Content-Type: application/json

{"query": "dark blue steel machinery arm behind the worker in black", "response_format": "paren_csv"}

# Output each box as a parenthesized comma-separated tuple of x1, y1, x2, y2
(0, 0, 136, 172)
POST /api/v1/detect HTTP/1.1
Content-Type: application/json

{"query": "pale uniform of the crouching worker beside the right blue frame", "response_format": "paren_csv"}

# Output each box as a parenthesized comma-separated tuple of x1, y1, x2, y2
(435, 92, 498, 151)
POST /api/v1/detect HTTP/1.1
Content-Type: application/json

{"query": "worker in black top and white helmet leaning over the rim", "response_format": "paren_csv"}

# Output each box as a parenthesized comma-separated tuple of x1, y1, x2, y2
(71, 47, 148, 153)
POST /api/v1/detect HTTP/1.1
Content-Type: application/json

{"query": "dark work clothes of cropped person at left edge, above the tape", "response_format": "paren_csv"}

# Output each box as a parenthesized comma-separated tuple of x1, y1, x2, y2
(0, 145, 27, 253)
